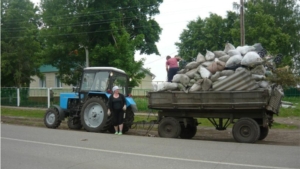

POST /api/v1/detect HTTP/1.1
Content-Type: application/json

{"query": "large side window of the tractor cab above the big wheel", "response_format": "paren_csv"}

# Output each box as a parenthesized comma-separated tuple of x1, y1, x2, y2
(81, 72, 109, 91)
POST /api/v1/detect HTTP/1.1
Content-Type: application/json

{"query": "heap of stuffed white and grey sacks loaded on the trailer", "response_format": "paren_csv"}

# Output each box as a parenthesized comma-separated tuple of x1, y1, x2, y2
(153, 43, 276, 92)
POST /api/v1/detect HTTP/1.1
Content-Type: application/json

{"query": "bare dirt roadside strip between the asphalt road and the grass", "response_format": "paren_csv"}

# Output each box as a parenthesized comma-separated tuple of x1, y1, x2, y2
(1, 116, 300, 146)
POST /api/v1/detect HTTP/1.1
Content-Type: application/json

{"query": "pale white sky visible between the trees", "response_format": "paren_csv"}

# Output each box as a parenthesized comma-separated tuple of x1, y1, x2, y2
(31, 0, 239, 81)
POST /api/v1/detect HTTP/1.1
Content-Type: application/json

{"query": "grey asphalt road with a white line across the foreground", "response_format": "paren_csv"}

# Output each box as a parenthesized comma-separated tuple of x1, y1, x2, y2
(1, 124, 300, 169)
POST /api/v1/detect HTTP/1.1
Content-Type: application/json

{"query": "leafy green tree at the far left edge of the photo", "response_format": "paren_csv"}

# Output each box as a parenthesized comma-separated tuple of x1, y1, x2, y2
(1, 0, 42, 87)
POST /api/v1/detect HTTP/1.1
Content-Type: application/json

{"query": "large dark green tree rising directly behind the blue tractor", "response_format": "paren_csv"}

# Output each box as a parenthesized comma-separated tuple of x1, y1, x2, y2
(41, 0, 162, 84)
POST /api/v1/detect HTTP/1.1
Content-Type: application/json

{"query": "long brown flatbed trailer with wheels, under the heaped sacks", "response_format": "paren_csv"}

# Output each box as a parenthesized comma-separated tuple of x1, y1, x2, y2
(147, 86, 283, 143)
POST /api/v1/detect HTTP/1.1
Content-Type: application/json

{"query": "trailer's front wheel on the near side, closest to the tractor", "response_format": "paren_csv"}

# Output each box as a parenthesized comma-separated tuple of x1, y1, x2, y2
(158, 117, 181, 138)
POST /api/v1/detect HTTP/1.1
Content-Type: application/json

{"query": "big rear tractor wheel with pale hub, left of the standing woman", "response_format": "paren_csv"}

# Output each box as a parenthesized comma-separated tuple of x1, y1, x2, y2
(80, 97, 108, 132)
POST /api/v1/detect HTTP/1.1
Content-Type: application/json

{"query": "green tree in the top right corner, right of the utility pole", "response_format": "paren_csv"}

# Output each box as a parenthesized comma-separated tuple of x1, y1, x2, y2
(246, 0, 300, 75)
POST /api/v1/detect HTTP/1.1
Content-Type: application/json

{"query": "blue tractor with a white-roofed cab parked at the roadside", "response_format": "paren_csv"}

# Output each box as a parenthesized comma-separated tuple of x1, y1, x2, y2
(44, 67, 137, 133)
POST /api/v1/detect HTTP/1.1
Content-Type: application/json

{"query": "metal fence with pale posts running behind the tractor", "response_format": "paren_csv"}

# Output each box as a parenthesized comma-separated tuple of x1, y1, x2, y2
(1, 87, 151, 108)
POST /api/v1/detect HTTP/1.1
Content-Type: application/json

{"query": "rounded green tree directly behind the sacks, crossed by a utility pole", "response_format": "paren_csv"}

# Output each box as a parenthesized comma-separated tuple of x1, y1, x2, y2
(176, 1, 299, 65)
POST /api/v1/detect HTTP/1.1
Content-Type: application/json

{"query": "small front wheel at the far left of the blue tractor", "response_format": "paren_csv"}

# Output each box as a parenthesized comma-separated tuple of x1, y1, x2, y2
(44, 108, 61, 129)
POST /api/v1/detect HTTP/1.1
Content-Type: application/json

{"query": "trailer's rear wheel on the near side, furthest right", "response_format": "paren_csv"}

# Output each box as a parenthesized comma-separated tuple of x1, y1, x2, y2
(232, 117, 260, 143)
